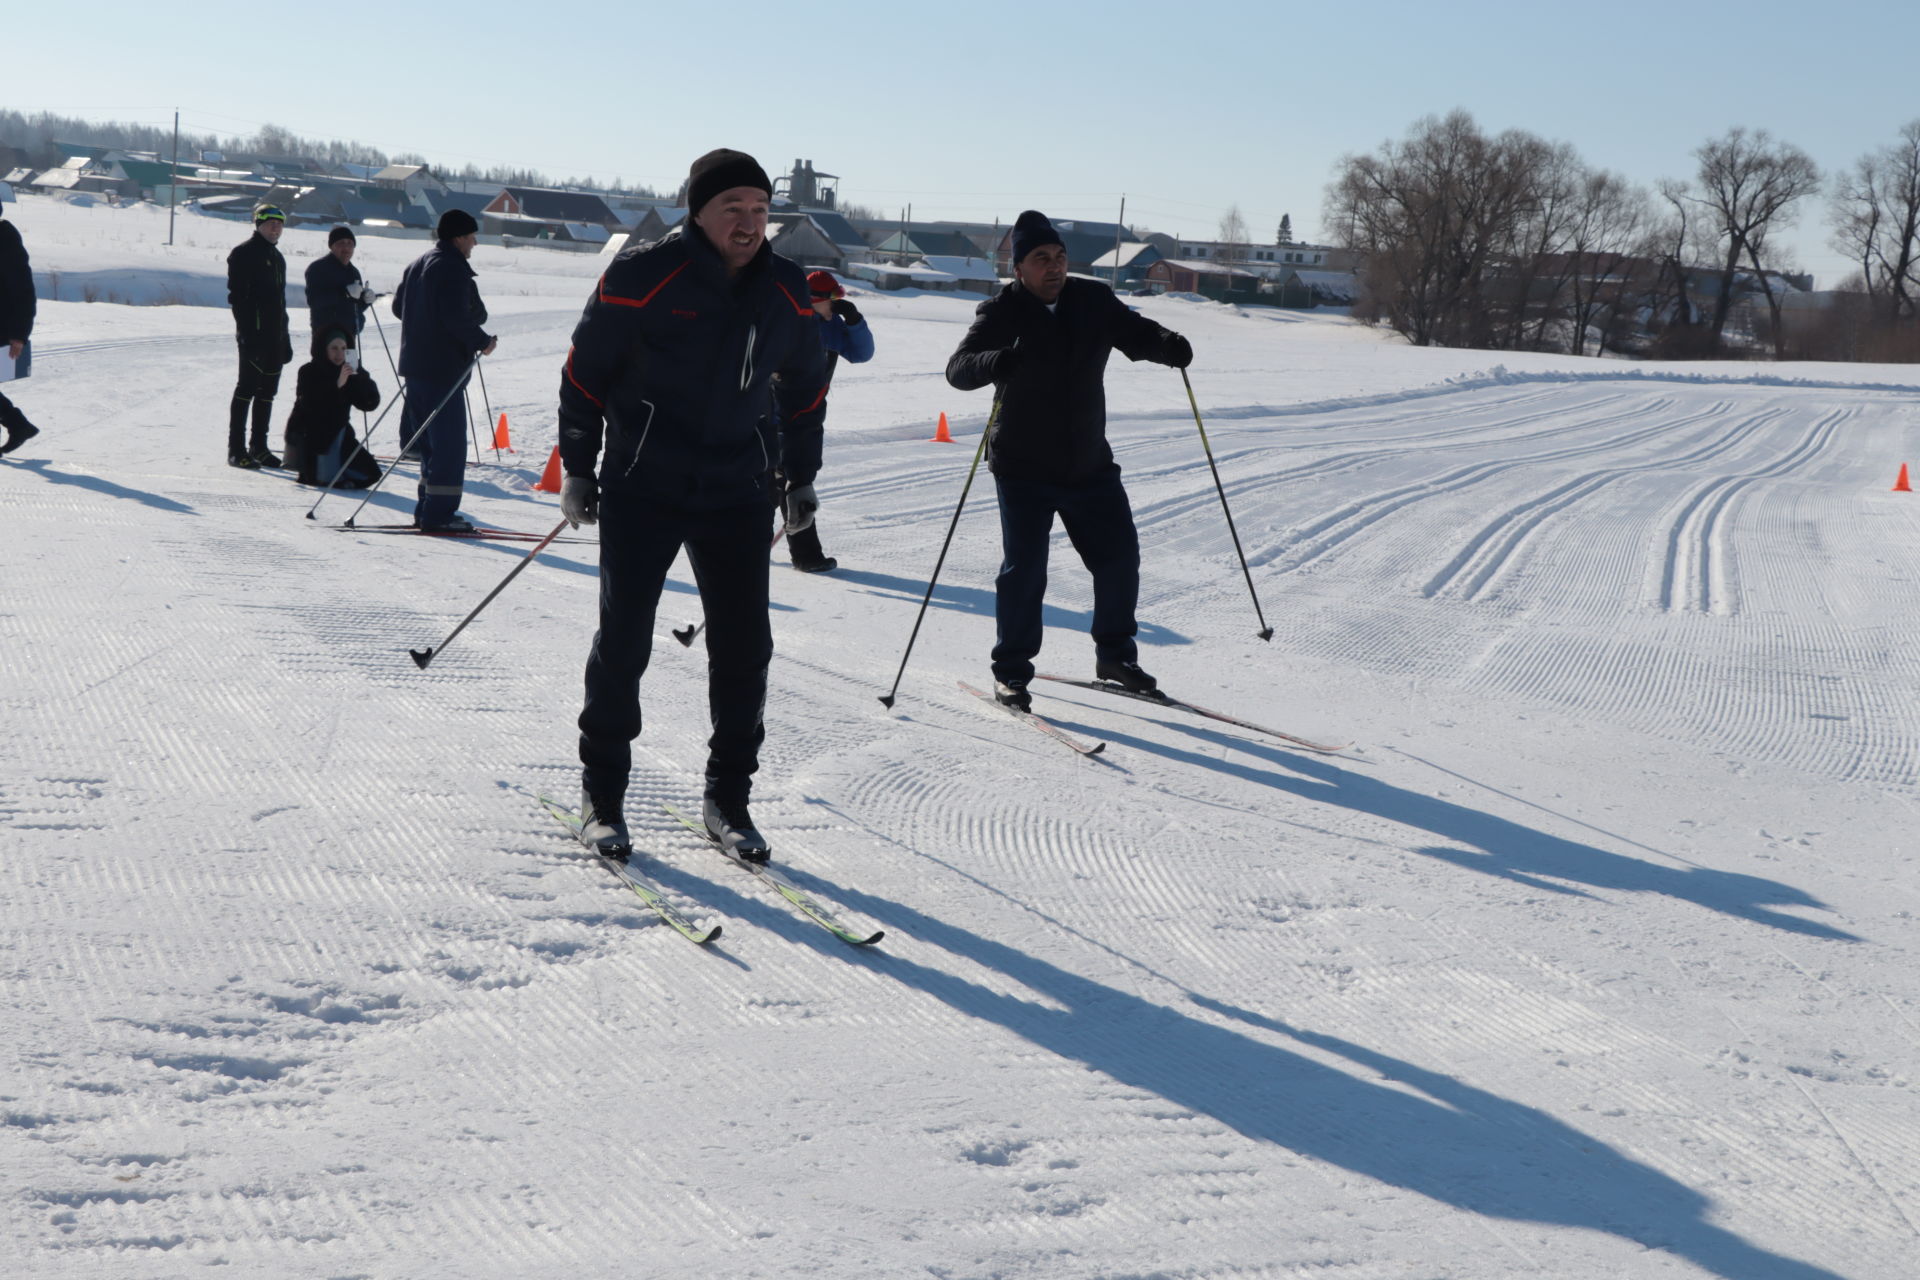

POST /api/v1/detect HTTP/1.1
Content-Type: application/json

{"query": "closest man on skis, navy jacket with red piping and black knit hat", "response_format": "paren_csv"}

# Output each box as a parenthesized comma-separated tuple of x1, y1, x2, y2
(559, 150, 828, 862)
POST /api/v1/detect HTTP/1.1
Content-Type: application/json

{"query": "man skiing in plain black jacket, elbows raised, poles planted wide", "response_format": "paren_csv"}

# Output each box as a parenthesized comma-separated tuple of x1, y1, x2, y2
(947, 209, 1194, 710)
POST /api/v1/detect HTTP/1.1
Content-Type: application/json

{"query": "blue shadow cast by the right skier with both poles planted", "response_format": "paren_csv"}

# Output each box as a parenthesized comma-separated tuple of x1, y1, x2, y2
(1052, 704, 1860, 942)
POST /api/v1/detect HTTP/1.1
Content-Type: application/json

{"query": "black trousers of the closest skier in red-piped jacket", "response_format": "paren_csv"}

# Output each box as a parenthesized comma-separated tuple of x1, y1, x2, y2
(580, 491, 774, 804)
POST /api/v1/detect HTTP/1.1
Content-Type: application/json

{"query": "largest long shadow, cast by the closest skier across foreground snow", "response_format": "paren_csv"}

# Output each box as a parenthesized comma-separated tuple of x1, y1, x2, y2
(810, 877, 1841, 1280)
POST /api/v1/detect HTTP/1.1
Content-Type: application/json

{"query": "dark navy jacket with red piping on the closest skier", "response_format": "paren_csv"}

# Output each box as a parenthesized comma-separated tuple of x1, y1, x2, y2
(561, 226, 828, 509)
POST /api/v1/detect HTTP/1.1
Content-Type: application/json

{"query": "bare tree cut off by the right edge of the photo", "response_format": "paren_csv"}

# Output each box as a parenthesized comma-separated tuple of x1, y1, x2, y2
(1832, 119, 1920, 326)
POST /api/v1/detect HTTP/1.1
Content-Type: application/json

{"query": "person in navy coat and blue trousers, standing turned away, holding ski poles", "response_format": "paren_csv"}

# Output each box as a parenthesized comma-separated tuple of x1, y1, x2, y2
(394, 209, 499, 533)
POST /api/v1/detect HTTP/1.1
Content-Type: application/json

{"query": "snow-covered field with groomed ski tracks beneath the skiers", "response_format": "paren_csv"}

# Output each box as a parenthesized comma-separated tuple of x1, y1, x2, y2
(0, 198, 1920, 1280)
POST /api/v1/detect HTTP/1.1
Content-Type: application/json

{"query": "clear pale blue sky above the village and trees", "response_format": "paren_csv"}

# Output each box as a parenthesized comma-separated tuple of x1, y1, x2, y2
(0, 0, 1920, 284)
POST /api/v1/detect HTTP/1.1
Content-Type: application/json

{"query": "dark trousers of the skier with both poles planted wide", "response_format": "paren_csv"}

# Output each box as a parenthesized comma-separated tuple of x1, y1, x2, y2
(993, 468, 1140, 683)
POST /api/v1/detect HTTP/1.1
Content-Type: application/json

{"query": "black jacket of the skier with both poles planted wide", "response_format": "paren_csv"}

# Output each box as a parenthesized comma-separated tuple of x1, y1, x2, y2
(947, 278, 1173, 484)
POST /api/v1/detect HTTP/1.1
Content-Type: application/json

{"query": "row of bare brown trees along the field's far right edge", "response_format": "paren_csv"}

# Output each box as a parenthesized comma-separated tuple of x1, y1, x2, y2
(1327, 111, 1920, 361)
